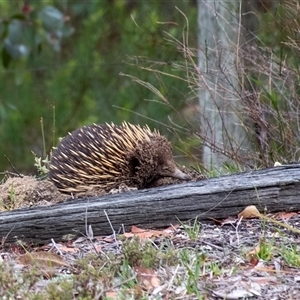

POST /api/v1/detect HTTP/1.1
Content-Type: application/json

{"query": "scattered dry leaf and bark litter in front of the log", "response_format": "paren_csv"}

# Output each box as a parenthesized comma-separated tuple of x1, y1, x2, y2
(0, 213, 300, 299)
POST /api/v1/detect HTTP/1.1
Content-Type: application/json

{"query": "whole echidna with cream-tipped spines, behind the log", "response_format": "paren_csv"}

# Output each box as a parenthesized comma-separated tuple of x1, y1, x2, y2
(49, 122, 190, 192)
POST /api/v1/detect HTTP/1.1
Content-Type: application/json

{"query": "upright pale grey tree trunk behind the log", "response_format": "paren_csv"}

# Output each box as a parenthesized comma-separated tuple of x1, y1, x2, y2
(198, 0, 257, 169)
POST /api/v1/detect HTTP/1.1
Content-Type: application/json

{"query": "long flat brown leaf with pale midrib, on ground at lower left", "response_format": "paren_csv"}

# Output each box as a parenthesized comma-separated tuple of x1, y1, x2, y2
(17, 251, 70, 268)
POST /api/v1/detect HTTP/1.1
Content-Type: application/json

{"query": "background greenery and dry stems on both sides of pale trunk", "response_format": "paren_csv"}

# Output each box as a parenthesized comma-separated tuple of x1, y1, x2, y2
(0, 0, 300, 174)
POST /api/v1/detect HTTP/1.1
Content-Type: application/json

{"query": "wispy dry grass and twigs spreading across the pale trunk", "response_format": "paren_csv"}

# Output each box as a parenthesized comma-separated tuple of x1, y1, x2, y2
(123, 1, 300, 171)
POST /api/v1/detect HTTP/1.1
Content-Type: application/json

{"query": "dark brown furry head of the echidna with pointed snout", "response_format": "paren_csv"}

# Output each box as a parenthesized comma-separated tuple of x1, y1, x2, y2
(127, 136, 190, 188)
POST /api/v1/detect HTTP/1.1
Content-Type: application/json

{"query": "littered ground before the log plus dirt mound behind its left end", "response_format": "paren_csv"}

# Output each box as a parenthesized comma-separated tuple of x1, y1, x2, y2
(0, 172, 300, 300)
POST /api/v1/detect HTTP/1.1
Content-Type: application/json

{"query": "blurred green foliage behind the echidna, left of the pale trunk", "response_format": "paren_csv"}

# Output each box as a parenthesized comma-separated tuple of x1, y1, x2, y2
(0, 0, 197, 174)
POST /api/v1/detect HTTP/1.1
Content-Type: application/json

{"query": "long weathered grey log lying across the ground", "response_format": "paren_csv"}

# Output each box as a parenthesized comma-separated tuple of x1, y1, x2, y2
(0, 164, 300, 243)
